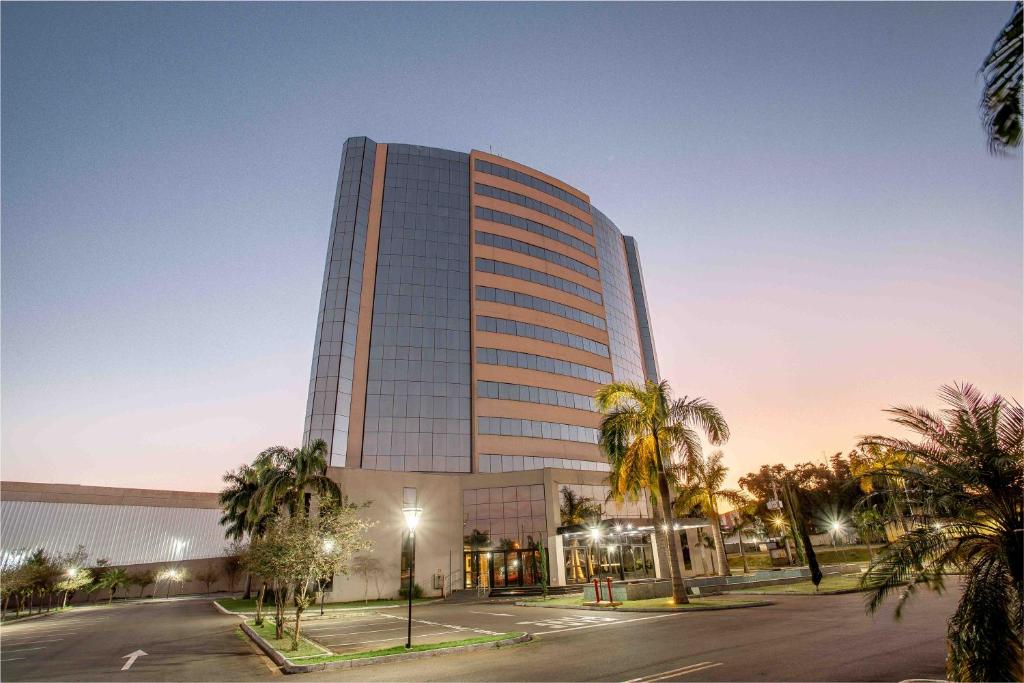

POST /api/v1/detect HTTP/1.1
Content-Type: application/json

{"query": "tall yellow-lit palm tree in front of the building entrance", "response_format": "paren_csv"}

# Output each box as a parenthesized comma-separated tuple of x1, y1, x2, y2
(596, 380, 729, 604)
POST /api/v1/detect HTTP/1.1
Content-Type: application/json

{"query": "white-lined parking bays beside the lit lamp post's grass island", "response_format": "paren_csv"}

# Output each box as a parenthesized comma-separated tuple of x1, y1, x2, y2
(302, 610, 501, 654)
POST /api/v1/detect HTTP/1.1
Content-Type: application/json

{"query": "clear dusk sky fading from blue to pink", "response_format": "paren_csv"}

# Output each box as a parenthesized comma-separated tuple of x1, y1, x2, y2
(0, 2, 1024, 489)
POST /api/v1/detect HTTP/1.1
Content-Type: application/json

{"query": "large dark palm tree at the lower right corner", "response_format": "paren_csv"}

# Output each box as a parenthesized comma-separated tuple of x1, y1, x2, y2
(862, 384, 1024, 681)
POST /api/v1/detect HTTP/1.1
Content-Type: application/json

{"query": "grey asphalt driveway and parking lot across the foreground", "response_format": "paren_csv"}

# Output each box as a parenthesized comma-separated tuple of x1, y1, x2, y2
(0, 587, 959, 683)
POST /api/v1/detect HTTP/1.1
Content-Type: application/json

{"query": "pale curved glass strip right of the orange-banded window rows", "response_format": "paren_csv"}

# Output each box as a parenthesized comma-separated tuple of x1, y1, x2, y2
(593, 208, 644, 384)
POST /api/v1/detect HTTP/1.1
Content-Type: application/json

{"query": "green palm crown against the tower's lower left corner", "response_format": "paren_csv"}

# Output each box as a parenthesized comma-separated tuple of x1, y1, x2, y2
(253, 439, 342, 515)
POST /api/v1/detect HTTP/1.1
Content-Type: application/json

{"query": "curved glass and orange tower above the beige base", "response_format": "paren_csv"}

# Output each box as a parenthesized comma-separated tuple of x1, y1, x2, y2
(305, 138, 657, 473)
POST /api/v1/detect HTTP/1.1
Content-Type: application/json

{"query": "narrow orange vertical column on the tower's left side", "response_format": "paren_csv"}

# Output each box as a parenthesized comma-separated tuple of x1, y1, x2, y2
(345, 144, 387, 467)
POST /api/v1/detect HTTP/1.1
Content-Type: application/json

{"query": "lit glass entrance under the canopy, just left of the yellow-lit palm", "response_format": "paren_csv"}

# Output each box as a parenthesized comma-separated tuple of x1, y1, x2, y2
(557, 519, 656, 584)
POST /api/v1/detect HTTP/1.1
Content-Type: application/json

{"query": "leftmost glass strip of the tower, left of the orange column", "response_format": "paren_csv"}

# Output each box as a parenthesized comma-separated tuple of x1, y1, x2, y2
(303, 137, 377, 467)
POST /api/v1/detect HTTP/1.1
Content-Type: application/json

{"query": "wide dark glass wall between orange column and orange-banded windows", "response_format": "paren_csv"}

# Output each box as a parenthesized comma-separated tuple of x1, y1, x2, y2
(362, 144, 471, 472)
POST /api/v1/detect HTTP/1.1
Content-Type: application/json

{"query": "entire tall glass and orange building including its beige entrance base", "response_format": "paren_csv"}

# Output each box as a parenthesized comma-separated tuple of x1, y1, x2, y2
(303, 137, 708, 588)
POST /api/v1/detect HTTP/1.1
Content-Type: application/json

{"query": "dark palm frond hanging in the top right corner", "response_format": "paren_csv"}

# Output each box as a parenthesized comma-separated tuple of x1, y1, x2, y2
(981, 1, 1024, 154)
